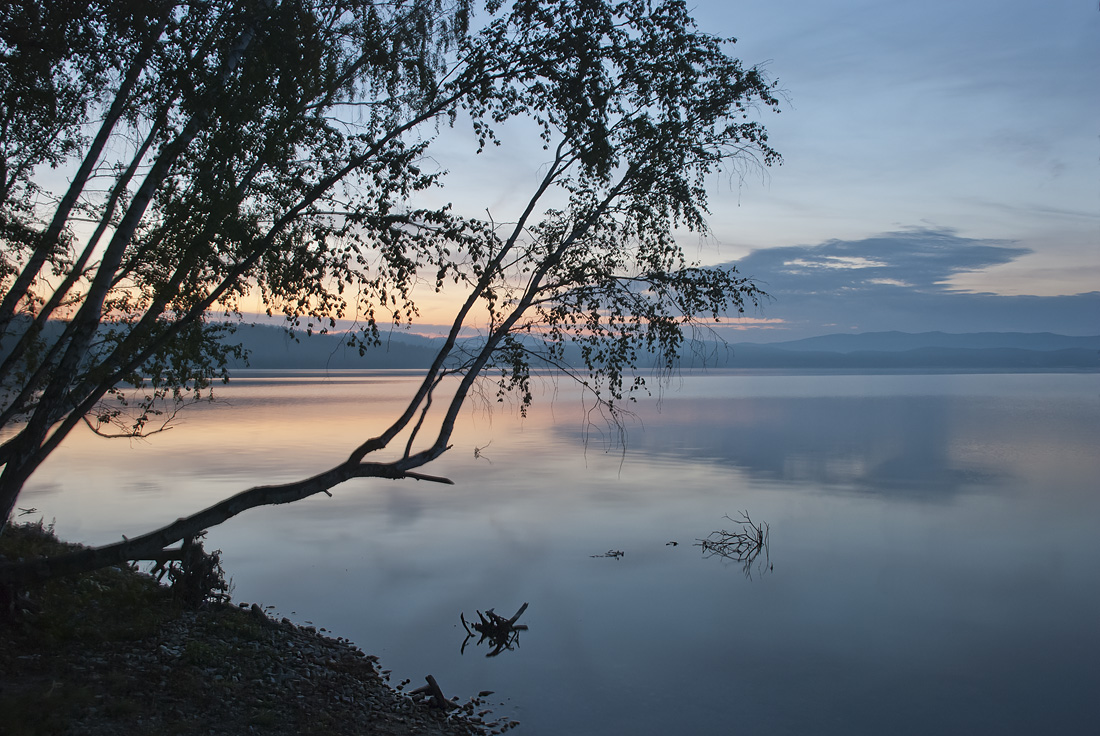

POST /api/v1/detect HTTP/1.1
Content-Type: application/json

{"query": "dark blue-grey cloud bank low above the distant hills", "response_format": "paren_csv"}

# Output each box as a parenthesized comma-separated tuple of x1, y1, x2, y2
(717, 228, 1100, 340)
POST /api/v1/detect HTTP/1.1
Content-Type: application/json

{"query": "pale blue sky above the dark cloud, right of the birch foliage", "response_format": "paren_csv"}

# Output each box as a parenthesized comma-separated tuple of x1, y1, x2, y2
(696, 0, 1100, 294)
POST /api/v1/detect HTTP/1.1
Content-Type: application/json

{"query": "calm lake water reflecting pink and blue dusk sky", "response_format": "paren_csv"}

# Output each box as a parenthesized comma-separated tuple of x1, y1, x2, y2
(19, 372, 1100, 736)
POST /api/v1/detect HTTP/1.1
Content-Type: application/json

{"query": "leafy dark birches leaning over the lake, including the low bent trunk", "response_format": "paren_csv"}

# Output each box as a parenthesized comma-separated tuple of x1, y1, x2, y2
(0, 0, 778, 583)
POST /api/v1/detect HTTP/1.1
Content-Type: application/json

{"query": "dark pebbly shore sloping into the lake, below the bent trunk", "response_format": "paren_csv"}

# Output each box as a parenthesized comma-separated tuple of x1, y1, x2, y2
(0, 527, 516, 736)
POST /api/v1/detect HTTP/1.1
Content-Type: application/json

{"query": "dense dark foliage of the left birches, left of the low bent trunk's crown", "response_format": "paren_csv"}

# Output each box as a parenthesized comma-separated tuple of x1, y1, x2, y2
(0, 0, 481, 501)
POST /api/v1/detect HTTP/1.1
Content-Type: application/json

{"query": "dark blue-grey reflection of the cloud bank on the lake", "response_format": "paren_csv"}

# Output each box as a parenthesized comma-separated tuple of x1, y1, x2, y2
(558, 396, 1010, 497)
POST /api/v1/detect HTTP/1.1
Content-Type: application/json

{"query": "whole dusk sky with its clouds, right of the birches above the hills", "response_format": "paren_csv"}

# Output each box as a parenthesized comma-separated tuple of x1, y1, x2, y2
(400, 0, 1100, 341)
